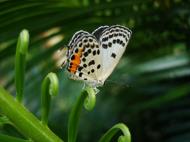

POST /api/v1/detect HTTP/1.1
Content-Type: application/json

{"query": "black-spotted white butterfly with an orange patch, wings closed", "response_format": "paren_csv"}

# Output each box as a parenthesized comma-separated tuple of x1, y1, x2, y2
(61, 25, 132, 88)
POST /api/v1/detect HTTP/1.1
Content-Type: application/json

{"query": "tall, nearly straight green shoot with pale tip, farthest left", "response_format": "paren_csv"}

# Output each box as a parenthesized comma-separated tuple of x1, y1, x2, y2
(15, 30, 29, 102)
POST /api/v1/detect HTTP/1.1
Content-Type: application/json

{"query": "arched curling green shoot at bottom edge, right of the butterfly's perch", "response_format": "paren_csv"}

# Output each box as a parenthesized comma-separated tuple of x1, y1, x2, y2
(99, 123, 131, 142)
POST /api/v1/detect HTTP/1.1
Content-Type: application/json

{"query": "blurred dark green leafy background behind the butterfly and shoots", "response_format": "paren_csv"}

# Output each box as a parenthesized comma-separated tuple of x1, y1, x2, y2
(0, 0, 190, 142)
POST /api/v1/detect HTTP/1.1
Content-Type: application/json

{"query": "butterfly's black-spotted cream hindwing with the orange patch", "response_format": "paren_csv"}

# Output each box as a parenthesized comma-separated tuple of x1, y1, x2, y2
(67, 34, 101, 82)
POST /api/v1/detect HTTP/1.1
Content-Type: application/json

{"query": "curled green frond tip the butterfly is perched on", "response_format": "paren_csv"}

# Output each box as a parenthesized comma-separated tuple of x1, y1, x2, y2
(68, 87, 96, 142)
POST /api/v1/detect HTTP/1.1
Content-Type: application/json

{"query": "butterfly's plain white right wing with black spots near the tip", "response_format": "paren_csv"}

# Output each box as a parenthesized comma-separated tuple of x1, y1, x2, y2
(98, 25, 132, 82)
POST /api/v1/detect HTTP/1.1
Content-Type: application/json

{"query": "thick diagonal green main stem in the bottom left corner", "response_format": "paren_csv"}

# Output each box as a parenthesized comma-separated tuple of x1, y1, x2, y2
(0, 86, 63, 142)
